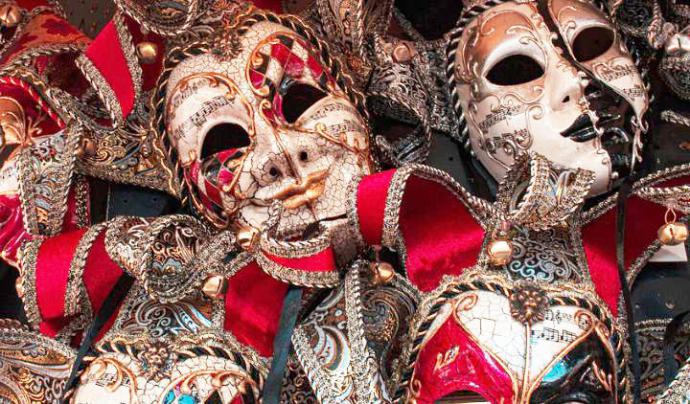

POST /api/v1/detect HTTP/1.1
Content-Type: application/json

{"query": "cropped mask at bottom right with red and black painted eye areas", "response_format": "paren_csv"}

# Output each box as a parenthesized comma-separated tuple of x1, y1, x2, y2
(409, 280, 625, 404)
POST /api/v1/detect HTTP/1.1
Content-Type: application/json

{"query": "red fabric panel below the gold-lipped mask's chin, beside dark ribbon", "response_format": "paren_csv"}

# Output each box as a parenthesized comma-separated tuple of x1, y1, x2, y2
(225, 261, 288, 356)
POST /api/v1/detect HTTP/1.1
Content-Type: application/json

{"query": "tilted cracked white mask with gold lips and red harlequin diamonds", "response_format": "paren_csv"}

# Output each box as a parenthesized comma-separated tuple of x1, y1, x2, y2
(166, 22, 370, 236)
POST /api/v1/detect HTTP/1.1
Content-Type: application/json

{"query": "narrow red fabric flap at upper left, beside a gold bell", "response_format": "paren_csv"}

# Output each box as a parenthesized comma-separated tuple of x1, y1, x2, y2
(84, 21, 135, 119)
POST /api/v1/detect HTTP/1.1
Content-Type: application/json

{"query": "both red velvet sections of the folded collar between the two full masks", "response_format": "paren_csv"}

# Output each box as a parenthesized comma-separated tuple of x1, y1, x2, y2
(357, 171, 484, 291)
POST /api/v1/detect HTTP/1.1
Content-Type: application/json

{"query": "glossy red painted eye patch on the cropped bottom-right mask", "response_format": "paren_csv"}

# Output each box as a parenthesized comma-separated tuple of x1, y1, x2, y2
(414, 316, 515, 404)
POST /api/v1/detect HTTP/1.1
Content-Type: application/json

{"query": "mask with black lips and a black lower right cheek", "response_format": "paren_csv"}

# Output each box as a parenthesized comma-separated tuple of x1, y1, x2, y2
(448, 0, 649, 194)
